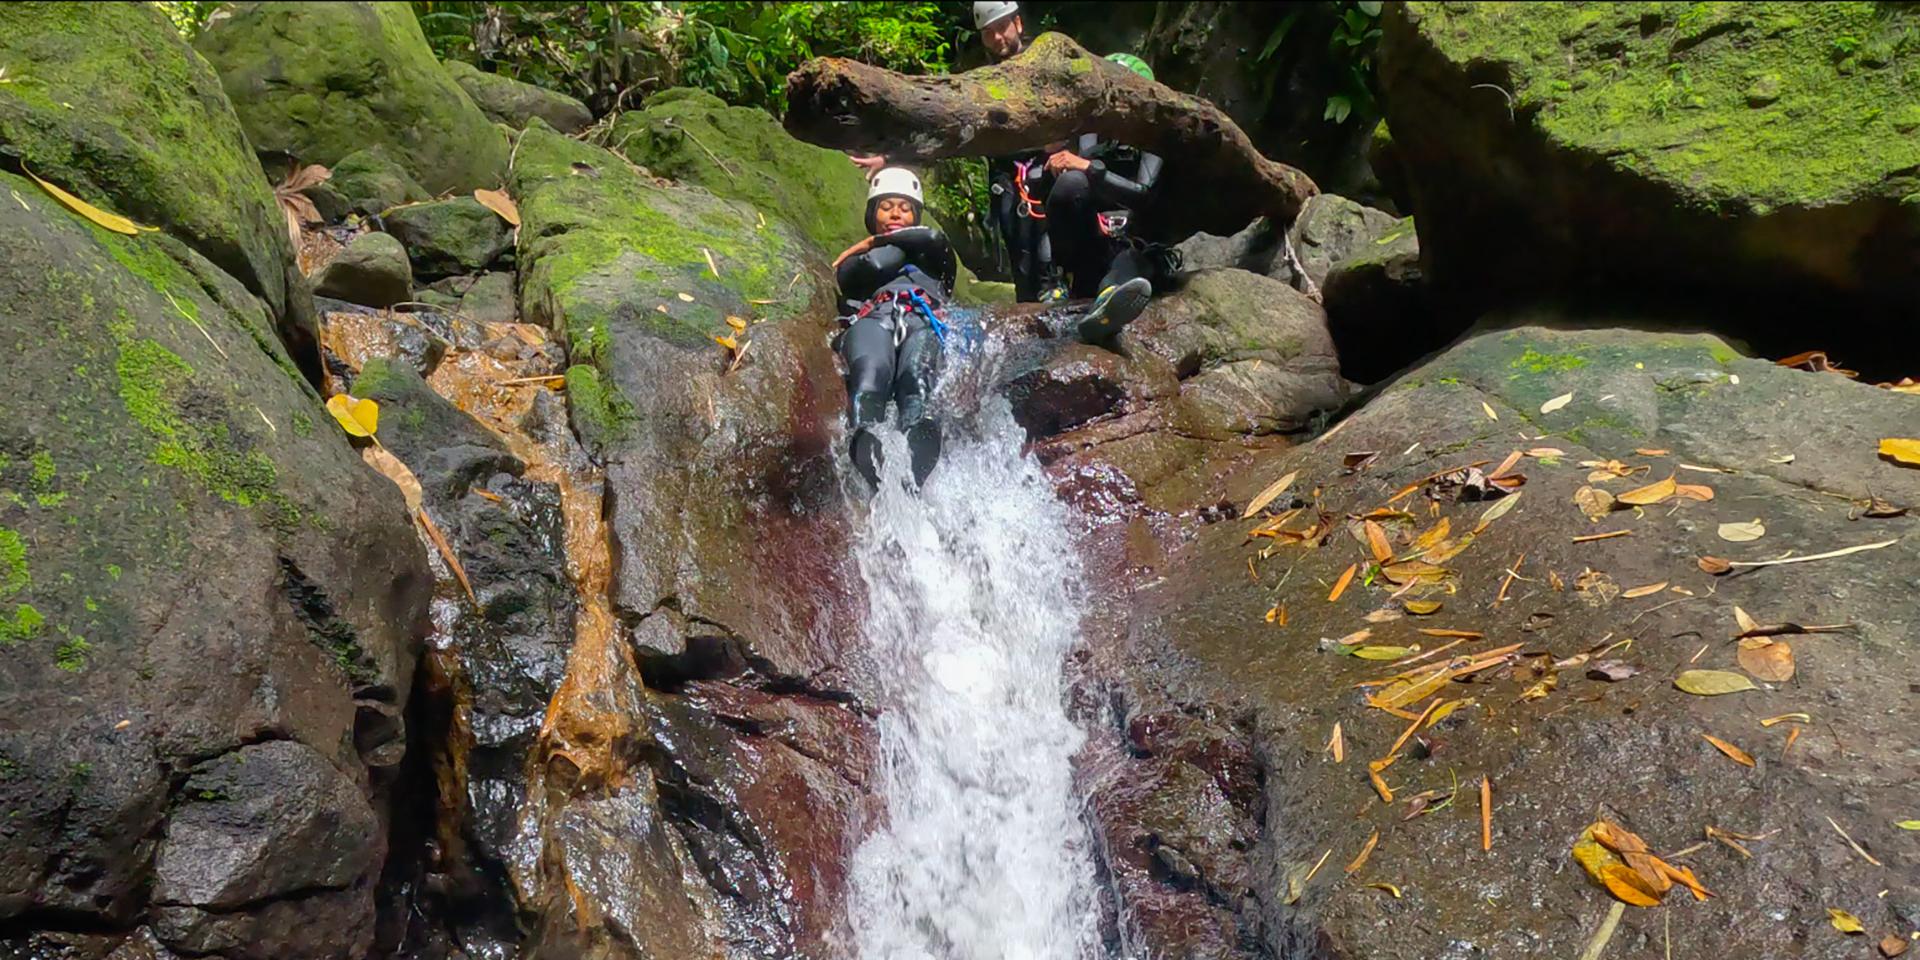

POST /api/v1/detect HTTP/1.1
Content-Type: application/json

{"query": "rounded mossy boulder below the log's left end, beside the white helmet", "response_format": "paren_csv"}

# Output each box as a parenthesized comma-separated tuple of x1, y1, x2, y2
(611, 86, 1012, 303)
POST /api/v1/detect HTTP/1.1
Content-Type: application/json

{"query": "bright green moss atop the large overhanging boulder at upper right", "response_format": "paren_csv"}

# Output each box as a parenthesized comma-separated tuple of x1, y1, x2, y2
(1407, 2, 1920, 207)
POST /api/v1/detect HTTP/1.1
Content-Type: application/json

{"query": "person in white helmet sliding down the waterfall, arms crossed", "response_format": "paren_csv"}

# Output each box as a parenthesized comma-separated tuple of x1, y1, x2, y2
(833, 167, 958, 488)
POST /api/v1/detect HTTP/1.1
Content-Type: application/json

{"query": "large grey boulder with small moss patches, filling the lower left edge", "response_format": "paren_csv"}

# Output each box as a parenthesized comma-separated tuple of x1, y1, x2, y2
(0, 173, 432, 956)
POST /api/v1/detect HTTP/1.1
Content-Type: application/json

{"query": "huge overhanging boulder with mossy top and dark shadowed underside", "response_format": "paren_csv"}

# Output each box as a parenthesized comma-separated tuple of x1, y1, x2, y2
(1380, 2, 1920, 355)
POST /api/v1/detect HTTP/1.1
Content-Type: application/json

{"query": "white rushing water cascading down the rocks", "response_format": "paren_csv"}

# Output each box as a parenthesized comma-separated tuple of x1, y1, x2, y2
(851, 322, 1096, 960)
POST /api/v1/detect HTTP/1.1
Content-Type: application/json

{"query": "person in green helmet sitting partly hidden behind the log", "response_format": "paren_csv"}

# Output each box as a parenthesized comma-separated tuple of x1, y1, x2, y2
(1041, 54, 1175, 344)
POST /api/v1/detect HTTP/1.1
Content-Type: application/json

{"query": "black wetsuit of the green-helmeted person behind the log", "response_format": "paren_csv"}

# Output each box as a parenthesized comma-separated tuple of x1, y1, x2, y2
(1046, 134, 1165, 298)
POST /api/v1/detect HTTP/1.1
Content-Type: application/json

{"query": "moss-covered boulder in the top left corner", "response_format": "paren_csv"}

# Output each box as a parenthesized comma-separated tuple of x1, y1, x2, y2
(0, 4, 317, 371)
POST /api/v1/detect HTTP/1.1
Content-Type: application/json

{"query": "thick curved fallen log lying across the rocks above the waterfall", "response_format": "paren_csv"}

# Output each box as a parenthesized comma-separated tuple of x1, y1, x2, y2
(787, 33, 1319, 240)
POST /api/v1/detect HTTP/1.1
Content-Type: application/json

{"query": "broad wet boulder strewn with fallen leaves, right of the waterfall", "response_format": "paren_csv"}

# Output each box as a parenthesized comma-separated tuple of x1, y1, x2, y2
(1083, 326, 1920, 958)
